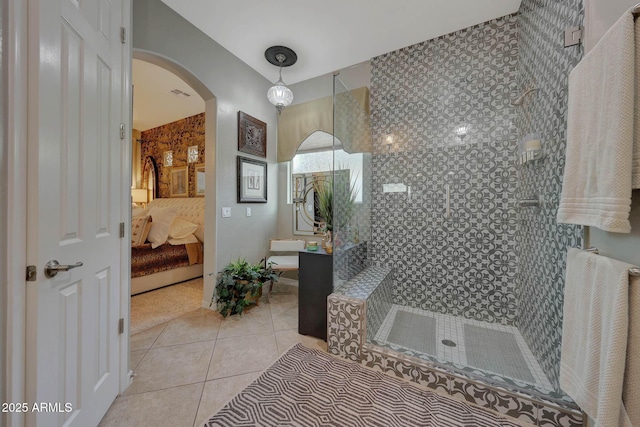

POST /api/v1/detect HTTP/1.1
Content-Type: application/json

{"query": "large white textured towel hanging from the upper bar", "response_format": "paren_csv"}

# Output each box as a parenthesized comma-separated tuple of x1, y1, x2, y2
(557, 11, 640, 233)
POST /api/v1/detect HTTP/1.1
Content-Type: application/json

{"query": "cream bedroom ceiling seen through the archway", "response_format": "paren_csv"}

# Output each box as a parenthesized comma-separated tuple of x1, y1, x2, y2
(133, 59, 204, 131)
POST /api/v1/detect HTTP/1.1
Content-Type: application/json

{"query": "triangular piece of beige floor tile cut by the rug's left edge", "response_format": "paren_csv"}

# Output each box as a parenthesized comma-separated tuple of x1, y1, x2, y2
(194, 372, 260, 426)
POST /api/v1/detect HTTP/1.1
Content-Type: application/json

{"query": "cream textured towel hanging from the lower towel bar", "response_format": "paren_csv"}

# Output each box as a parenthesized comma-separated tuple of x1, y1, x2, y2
(560, 249, 632, 427)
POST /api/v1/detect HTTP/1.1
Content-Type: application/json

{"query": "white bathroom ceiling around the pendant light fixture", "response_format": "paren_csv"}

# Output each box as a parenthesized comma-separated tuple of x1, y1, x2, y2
(162, 0, 521, 84)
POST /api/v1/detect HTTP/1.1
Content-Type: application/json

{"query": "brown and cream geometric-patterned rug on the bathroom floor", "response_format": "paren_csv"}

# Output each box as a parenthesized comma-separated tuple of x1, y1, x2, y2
(205, 344, 519, 427)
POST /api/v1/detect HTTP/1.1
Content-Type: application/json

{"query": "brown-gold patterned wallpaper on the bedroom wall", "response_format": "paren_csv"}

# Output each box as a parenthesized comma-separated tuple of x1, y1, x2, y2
(141, 113, 204, 198)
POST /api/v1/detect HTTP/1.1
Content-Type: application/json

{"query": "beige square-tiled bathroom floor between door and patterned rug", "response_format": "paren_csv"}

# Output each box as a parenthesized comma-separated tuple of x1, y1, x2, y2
(100, 285, 326, 427)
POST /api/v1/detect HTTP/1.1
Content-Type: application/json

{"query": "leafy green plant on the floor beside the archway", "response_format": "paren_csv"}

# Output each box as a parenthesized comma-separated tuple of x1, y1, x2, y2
(209, 258, 278, 317)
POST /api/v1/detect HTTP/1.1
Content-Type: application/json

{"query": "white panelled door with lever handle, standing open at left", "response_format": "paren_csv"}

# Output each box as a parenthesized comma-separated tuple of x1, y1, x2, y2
(26, 0, 130, 427)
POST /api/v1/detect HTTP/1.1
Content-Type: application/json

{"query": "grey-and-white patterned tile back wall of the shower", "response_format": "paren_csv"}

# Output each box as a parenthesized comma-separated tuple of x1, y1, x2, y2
(369, 15, 518, 324)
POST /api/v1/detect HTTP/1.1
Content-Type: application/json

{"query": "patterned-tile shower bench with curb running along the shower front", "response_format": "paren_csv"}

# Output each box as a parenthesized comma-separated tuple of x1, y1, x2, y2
(327, 266, 582, 427)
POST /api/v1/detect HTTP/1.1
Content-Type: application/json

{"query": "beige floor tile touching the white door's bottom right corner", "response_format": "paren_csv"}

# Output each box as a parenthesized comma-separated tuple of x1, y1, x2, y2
(125, 341, 215, 395)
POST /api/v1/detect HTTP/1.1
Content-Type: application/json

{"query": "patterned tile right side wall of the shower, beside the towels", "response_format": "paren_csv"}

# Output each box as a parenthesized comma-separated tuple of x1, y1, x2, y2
(516, 0, 583, 389)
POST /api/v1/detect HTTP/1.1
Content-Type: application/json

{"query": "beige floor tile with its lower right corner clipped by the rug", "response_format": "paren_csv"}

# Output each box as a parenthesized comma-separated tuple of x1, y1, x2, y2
(207, 331, 278, 380)
